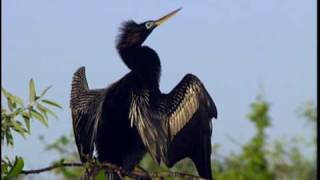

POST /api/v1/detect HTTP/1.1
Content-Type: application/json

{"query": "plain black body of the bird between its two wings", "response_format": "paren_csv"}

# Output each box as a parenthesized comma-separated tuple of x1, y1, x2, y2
(96, 73, 146, 170)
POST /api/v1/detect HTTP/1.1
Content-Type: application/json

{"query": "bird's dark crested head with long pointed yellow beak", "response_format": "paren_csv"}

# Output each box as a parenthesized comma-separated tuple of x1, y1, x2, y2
(117, 8, 181, 50)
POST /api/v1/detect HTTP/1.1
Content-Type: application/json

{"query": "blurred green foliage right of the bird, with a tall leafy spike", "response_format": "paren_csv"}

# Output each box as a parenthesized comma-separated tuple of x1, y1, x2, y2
(213, 97, 317, 180)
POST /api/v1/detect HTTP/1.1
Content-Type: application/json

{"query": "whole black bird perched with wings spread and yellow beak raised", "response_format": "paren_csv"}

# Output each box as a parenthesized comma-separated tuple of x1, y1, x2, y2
(70, 9, 217, 179)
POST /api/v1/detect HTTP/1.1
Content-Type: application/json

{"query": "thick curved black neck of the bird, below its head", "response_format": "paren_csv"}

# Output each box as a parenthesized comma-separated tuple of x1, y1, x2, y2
(118, 45, 161, 89)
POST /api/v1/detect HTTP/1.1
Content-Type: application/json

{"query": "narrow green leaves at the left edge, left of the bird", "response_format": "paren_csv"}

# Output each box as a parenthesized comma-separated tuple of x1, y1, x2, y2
(1, 79, 61, 179)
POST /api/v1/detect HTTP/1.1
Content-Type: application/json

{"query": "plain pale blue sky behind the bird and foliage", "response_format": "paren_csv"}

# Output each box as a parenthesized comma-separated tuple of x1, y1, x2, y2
(2, 0, 317, 177)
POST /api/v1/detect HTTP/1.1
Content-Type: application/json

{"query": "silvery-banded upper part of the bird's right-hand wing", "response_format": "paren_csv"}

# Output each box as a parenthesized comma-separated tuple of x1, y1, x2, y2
(161, 74, 217, 141)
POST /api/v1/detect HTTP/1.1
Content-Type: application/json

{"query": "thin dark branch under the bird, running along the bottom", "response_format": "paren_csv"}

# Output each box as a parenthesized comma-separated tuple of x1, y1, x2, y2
(20, 163, 205, 180)
